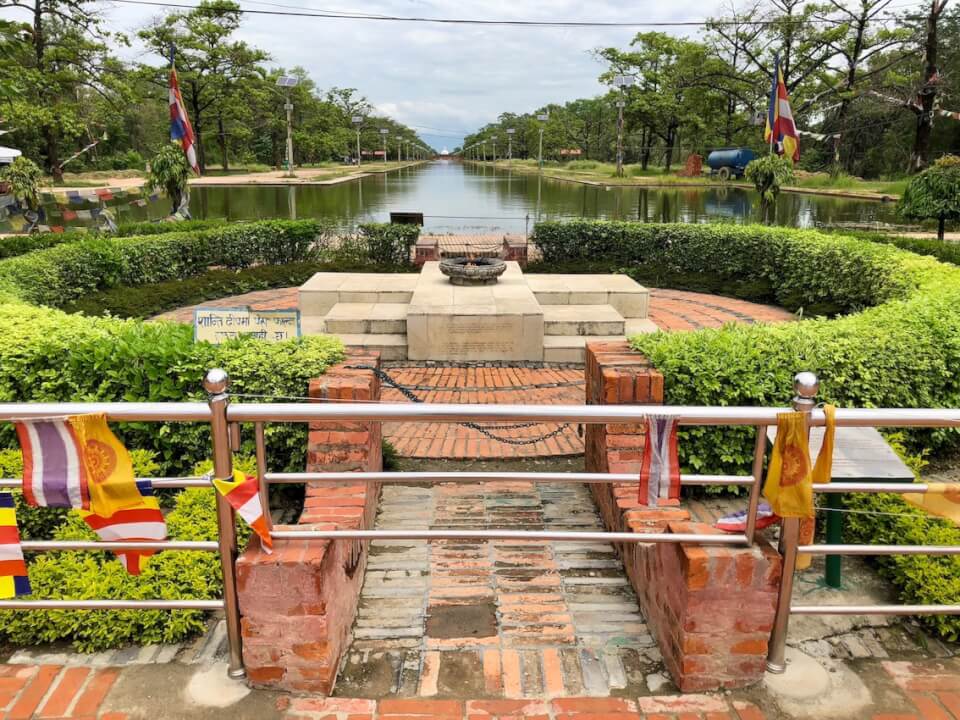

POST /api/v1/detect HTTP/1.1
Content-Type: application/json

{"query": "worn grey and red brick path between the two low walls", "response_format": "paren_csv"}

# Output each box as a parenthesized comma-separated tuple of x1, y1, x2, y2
(336, 482, 666, 698)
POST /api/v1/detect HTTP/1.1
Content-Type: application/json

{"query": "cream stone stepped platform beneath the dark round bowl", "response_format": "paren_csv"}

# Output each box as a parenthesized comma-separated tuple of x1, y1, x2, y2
(299, 261, 657, 363)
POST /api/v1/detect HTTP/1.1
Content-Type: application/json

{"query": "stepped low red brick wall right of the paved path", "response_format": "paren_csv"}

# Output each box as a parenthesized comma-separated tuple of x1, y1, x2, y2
(585, 342, 780, 692)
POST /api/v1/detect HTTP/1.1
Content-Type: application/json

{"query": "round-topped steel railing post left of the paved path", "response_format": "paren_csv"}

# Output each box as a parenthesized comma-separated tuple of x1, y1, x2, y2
(203, 368, 247, 678)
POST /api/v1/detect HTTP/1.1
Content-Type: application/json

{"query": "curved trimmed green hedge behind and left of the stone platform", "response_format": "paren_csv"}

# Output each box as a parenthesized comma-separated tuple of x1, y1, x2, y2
(0, 220, 321, 307)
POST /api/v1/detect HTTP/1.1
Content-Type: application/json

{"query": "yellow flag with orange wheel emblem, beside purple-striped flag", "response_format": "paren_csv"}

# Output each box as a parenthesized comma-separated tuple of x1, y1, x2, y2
(70, 414, 143, 518)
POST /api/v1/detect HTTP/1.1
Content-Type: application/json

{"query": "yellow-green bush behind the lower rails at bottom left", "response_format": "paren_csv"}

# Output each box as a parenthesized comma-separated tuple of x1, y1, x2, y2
(0, 488, 249, 652)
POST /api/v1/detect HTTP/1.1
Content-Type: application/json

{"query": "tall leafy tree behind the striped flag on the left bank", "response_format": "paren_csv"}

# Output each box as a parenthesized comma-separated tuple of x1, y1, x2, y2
(139, 0, 269, 171)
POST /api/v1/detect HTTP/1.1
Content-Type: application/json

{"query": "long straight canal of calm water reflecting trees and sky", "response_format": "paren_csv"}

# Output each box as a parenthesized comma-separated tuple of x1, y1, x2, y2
(35, 161, 896, 233)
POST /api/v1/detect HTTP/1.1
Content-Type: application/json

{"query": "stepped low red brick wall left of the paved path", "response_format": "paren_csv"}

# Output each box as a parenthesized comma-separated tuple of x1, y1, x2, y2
(237, 353, 383, 693)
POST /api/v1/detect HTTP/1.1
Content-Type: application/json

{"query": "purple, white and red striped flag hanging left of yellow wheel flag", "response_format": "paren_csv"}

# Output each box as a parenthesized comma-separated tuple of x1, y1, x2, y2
(15, 418, 90, 510)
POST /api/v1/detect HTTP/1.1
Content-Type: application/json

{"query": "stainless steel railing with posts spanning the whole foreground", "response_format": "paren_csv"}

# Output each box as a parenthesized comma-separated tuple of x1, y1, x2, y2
(0, 369, 960, 677)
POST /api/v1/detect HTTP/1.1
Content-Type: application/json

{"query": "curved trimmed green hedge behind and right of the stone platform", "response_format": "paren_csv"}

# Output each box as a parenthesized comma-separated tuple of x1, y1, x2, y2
(533, 220, 915, 315)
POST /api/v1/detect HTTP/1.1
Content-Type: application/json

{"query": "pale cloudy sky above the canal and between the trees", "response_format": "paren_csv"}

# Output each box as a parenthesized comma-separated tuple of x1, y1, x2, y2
(94, 0, 722, 150)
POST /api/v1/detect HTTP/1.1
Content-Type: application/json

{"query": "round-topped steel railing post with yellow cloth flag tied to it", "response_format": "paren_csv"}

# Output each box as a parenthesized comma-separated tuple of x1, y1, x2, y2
(767, 372, 820, 675)
